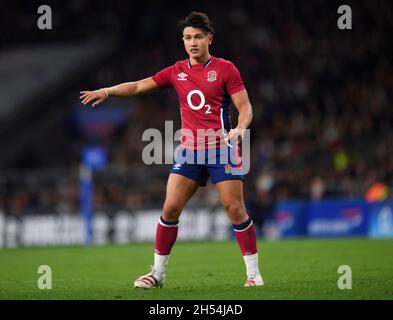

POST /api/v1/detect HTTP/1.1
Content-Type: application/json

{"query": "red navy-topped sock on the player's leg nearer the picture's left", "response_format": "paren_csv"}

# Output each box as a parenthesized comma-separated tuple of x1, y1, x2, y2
(154, 217, 179, 256)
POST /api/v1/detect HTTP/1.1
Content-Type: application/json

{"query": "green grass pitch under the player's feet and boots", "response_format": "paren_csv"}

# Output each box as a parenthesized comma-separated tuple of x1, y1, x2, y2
(0, 239, 393, 300)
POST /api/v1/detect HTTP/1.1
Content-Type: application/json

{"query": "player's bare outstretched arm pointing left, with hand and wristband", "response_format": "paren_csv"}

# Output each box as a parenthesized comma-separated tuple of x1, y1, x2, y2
(79, 77, 158, 107)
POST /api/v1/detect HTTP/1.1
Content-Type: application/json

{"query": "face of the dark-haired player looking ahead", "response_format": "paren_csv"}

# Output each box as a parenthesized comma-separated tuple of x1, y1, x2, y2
(183, 27, 213, 60)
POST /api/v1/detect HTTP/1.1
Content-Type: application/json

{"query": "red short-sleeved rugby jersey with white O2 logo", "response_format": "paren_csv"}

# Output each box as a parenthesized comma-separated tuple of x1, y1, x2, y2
(153, 56, 245, 149)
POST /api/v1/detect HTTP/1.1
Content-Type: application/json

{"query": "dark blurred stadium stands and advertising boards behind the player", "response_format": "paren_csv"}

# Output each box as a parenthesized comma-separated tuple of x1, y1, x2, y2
(0, 0, 393, 300)
